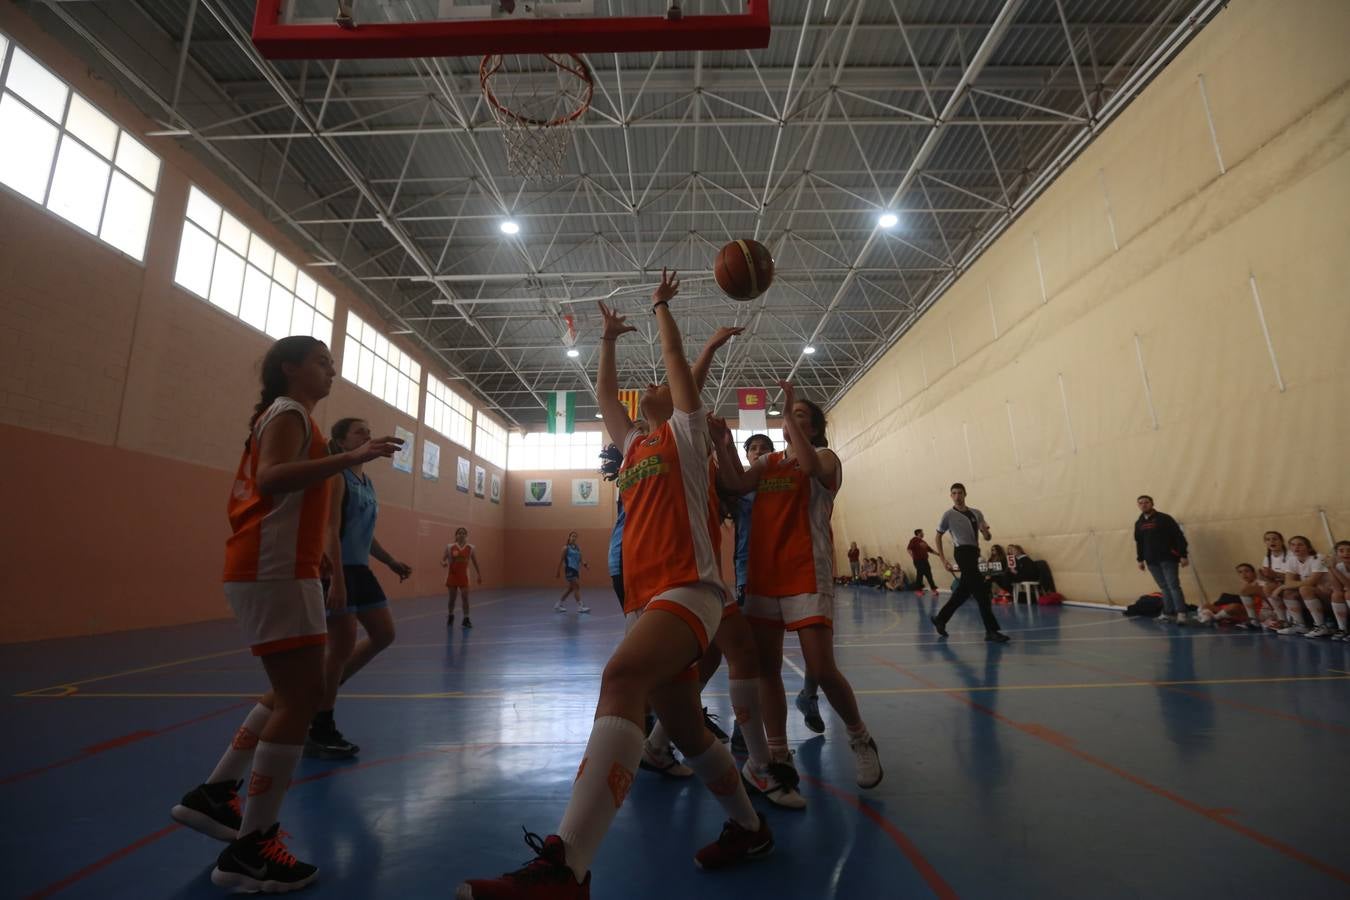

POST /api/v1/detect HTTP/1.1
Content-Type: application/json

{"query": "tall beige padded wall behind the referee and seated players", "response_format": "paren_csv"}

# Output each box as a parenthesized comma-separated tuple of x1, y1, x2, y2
(830, 0, 1350, 604)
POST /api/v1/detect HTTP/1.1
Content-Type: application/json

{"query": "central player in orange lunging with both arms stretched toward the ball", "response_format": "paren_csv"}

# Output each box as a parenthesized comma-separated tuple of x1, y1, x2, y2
(455, 271, 774, 900)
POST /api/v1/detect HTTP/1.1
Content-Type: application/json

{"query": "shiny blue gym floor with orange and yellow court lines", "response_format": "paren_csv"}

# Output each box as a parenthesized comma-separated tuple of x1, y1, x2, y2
(0, 588, 1350, 900)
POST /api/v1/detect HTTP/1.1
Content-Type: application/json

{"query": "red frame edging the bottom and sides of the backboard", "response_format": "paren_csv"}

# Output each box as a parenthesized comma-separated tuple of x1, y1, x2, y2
(252, 0, 770, 59)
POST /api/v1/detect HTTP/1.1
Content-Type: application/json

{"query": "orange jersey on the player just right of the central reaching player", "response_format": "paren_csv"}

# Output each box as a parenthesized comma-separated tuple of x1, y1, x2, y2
(745, 451, 837, 596)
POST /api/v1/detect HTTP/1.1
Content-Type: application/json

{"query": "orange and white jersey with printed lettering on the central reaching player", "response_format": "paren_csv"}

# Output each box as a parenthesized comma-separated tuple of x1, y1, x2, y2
(618, 410, 726, 613)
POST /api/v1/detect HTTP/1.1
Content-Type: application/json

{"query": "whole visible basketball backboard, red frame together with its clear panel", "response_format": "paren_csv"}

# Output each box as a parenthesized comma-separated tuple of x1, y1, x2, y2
(252, 0, 770, 59)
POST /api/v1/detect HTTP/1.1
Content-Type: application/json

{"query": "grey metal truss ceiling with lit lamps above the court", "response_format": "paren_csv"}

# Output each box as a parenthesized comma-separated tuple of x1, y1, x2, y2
(42, 0, 1222, 425)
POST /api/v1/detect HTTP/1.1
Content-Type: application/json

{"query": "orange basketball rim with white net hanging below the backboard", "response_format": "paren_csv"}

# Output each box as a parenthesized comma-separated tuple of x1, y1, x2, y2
(478, 53, 595, 181)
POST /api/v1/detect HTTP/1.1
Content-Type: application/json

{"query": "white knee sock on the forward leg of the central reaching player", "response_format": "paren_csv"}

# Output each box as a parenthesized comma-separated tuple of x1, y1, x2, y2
(558, 715, 644, 881)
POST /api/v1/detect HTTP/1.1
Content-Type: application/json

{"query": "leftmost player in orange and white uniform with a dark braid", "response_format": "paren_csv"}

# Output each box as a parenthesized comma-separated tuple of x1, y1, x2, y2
(171, 336, 402, 892)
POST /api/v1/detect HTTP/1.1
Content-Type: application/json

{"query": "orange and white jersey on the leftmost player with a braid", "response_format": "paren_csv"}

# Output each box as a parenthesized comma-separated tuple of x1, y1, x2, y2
(224, 397, 329, 582)
